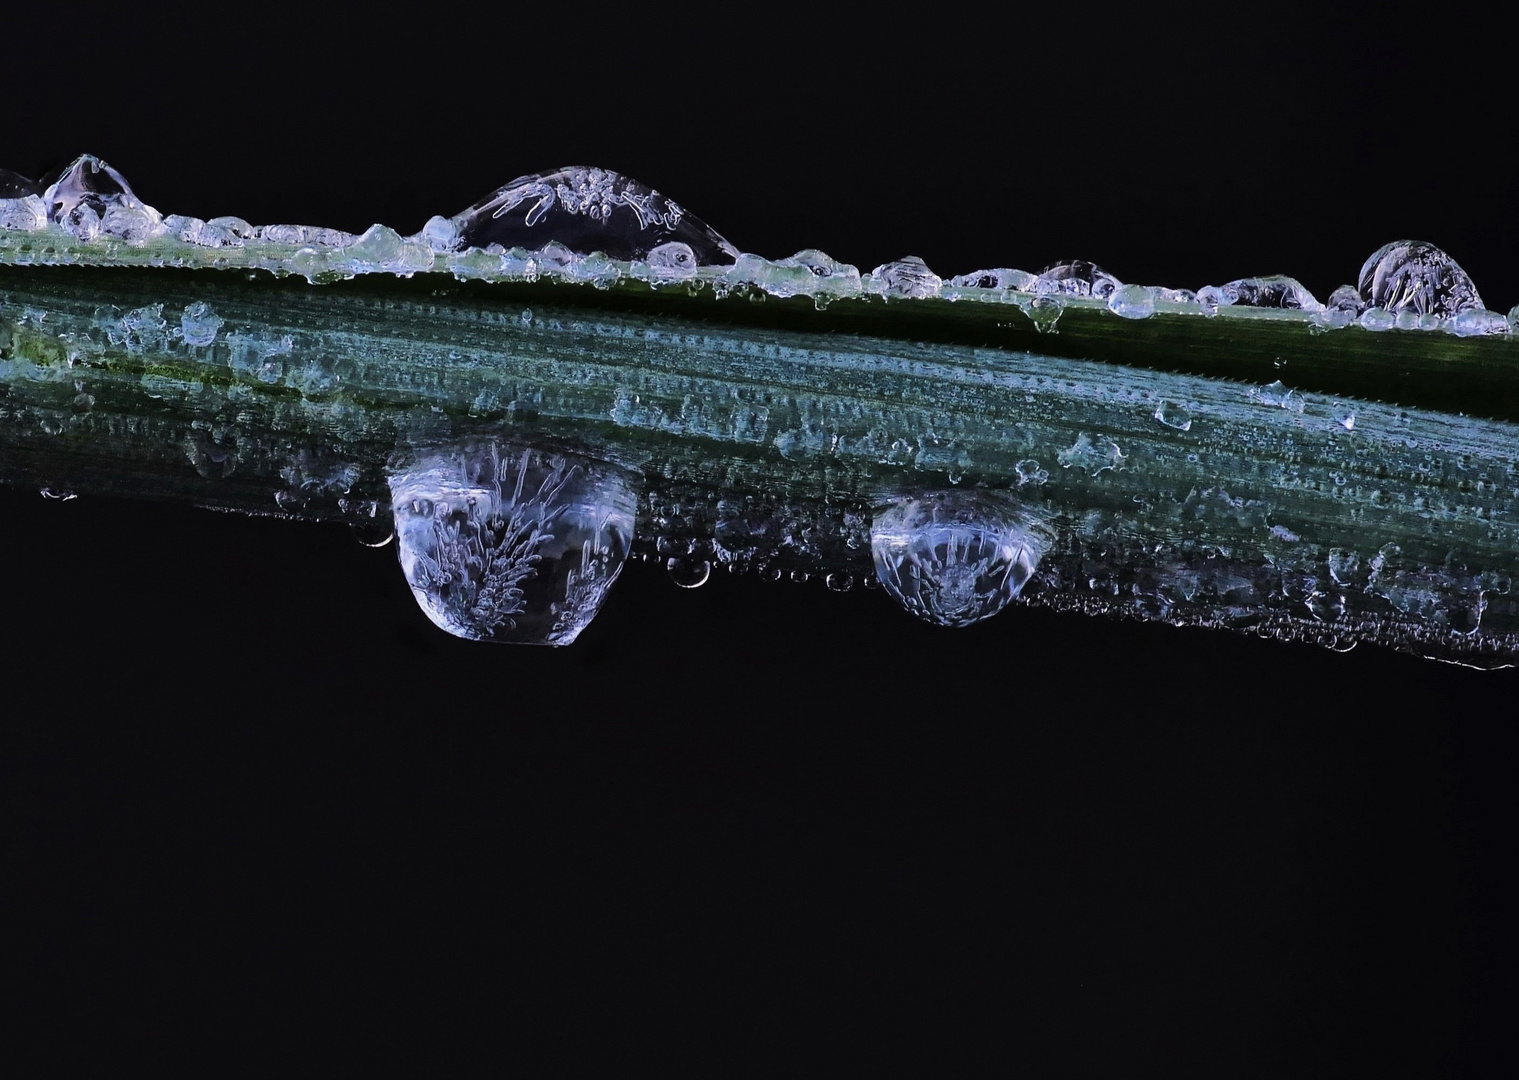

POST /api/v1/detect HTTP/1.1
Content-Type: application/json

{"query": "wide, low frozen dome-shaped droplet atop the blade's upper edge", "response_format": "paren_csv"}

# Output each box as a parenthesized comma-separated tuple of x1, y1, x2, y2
(443, 166, 738, 266)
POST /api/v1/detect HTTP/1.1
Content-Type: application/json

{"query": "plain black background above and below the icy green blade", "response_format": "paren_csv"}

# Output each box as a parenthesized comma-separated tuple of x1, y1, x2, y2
(0, 8, 1519, 1075)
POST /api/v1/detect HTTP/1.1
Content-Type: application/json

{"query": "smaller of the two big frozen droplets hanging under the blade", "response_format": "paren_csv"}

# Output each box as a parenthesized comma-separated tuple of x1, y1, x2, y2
(870, 491, 1048, 626)
